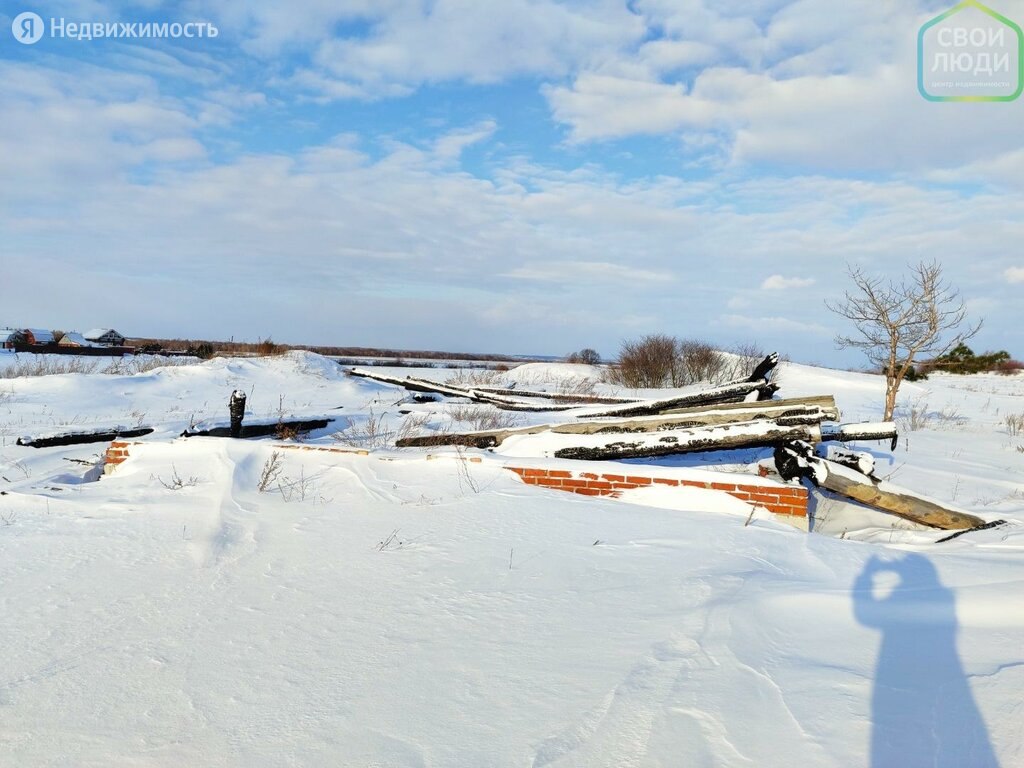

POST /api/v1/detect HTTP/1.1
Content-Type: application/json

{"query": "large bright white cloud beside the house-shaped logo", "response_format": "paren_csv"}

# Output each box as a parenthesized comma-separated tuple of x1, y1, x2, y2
(544, 0, 1020, 178)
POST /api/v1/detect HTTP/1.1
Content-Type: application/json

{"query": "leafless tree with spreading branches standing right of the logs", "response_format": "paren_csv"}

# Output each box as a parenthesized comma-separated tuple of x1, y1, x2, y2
(825, 261, 981, 421)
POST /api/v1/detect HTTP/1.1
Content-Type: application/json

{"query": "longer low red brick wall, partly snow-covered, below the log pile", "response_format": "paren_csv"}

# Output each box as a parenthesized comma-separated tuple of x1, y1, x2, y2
(506, 467, 807, 517)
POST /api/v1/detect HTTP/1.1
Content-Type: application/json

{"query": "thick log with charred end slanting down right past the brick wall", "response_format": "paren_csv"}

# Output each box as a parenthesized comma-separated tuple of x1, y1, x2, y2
(775, 441, 985, 530)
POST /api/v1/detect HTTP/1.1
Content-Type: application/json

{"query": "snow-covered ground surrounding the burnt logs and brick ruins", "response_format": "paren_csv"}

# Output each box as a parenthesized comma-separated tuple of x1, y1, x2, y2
(0, 352, 1024, 768)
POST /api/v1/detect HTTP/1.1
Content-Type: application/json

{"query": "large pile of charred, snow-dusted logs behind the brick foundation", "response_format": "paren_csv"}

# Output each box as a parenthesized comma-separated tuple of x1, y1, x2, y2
(350, 354, 985, 530)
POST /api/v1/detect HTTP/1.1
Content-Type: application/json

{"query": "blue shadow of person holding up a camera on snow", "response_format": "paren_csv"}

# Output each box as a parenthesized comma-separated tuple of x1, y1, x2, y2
(853, 554, 998, 768)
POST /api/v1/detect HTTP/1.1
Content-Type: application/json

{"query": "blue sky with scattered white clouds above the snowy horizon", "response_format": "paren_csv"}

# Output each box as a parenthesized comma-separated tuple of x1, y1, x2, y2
(0, 0, 1024, 366)
